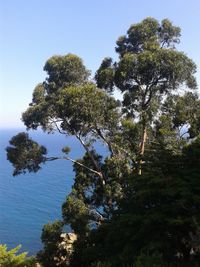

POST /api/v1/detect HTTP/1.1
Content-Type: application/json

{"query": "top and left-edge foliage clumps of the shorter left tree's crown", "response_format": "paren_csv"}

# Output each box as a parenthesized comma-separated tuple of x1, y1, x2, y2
(22, 54, 89, 131)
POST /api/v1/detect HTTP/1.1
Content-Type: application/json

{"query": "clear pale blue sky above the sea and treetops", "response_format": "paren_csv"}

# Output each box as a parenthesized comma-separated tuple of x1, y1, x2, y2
(0, 0, 200, 128)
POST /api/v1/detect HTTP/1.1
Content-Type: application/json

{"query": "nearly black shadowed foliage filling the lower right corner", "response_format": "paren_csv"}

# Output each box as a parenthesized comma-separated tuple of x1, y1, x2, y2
(72, 142, 200, 267)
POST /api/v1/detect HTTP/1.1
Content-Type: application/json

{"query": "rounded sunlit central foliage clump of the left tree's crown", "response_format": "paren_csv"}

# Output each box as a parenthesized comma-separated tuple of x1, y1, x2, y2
(55, 84, 118, 135)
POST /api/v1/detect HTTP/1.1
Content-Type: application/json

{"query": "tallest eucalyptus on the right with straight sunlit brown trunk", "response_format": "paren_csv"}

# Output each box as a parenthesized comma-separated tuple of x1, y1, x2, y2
(95, 17, 197, 174)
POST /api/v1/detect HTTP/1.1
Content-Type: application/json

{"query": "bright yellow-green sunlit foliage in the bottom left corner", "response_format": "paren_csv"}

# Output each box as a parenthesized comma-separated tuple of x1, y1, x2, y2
(0, 244, 35, 267)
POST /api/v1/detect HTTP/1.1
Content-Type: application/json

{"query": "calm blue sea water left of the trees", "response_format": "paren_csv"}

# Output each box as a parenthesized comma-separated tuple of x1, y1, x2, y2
(0, 129, 88, 255)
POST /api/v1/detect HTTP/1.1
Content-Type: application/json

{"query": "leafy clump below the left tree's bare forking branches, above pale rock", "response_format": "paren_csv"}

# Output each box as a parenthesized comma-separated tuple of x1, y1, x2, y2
(62, 151, 125, 236)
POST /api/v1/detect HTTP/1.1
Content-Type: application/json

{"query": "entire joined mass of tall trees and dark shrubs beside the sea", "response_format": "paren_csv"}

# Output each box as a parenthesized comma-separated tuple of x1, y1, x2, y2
(7, 18, 200, 267)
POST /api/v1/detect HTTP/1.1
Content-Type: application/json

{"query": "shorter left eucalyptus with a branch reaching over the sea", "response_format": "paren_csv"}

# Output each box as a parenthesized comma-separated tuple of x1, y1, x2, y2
(7, 54, 125, 232)
